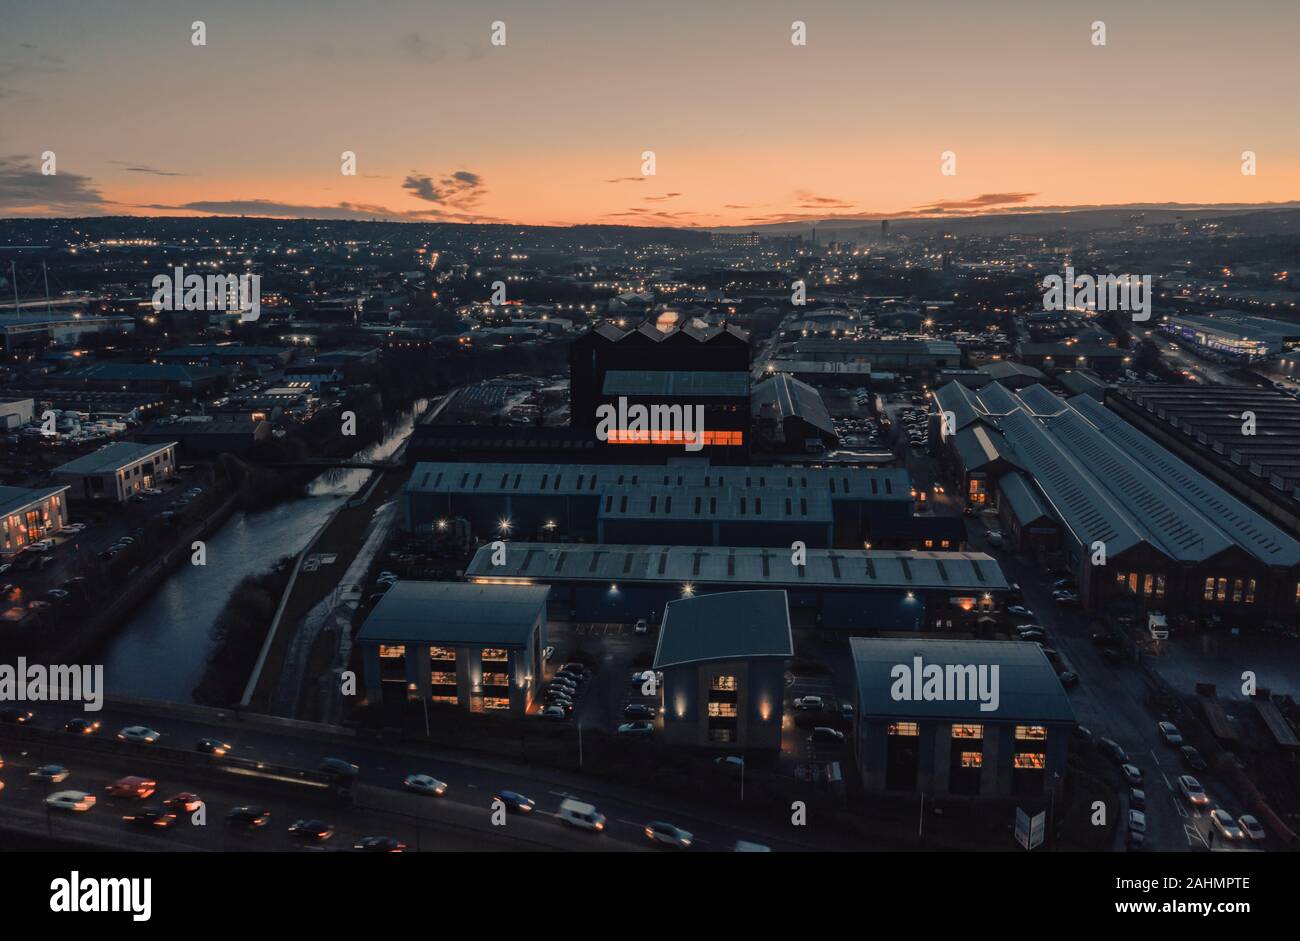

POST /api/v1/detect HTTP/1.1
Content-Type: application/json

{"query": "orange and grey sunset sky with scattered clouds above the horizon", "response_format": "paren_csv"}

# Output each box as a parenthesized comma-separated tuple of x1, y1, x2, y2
(0, 0, 1300, 226)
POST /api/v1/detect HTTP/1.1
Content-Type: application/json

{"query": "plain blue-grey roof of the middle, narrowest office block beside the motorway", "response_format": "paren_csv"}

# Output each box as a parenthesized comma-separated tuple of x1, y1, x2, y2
(654, 590, 794, 669)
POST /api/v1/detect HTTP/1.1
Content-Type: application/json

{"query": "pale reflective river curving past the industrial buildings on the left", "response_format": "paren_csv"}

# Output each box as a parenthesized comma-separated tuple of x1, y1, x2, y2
(100, 400, 426, 702)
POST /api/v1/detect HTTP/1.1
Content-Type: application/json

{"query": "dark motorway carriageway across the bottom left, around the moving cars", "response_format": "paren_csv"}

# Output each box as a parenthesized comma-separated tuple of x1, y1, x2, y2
(0, 703, 832, 851)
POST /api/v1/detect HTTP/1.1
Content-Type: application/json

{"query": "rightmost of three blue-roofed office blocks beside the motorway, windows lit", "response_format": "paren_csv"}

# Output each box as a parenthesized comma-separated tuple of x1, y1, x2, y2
(849, 637, 1076, 799)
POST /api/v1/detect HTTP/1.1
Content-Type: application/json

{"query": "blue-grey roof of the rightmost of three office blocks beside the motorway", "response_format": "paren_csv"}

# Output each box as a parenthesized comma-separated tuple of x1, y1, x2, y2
(849, 637, 1076, 723)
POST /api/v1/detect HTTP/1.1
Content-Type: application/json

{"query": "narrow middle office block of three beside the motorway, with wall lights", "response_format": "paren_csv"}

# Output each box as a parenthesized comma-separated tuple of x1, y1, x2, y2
(654, 590, 794, 751)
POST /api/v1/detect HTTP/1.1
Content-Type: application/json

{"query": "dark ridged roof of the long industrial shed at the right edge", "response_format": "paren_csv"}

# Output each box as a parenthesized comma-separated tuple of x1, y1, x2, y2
(1106, 385, 1300, 535)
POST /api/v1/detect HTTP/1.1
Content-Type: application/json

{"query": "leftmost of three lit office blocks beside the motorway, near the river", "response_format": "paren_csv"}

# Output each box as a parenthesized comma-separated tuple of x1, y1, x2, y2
(356, 581, 547, 716)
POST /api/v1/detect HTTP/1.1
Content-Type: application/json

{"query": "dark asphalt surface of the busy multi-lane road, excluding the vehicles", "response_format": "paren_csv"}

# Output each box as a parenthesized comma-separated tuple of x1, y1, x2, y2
(0, 703, 826, 850)
